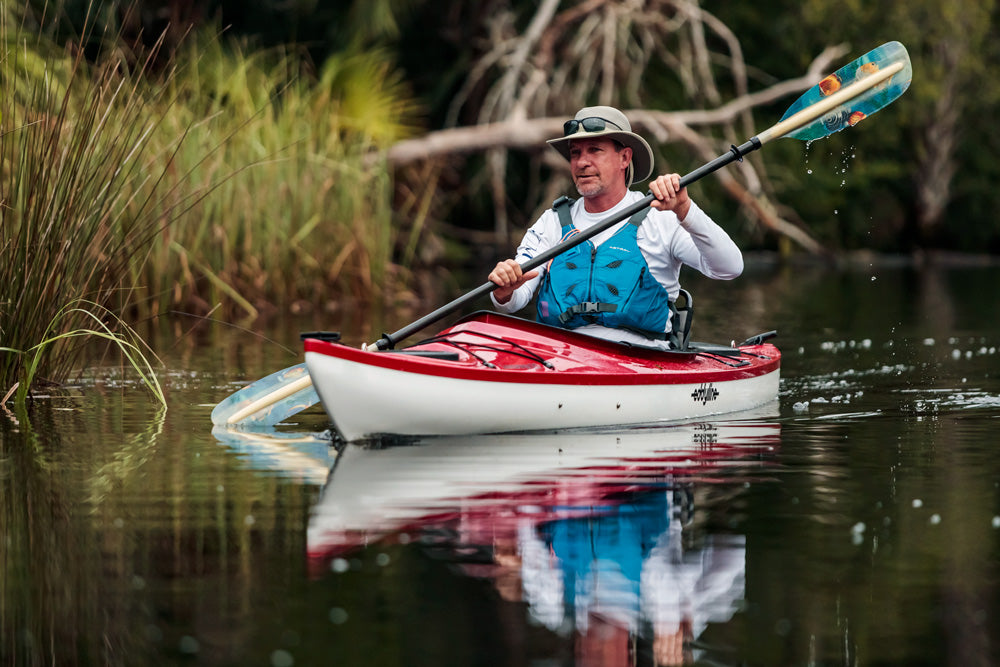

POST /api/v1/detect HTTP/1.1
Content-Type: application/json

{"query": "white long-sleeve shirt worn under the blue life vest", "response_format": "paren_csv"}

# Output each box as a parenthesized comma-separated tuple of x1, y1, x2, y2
(490, 190, 743, 345)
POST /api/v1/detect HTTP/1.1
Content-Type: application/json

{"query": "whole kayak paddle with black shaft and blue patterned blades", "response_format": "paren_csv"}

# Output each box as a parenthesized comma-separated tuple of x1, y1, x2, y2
(212, 42, 913, 425)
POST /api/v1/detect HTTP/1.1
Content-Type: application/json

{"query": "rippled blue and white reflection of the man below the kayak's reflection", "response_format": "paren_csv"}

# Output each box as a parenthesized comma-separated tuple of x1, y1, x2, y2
(462, 488, 746, 665)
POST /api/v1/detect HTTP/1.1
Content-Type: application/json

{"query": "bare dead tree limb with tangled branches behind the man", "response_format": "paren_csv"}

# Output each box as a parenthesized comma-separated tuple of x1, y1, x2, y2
(387, 0, 845, 252)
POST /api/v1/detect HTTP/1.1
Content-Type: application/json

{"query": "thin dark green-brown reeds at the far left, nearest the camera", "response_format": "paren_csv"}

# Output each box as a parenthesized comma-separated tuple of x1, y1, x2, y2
(0, 5, 197, 398)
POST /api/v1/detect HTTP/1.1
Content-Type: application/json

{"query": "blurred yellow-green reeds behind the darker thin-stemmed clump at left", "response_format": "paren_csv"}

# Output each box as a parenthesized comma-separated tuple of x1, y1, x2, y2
(129, 35, 412, 317)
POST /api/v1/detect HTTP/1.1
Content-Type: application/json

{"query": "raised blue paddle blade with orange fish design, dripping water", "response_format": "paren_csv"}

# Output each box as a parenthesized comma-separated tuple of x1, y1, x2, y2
(781, 42, 913, 141)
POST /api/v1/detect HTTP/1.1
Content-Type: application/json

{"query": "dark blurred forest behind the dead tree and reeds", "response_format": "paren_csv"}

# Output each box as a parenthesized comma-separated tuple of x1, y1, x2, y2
(25, 0, 1000, 252)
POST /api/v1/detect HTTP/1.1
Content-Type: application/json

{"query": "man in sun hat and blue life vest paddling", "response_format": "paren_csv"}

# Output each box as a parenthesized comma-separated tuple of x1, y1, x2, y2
(489, 106, 743, 347)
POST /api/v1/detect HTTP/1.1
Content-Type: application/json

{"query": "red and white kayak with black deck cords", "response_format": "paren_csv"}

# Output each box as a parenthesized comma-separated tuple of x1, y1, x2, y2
(303, 311, 781, 442)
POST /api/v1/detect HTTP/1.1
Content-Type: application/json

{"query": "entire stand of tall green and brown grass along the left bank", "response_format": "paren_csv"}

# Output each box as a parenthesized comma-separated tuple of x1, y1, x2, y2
(0, 3, 413, 394)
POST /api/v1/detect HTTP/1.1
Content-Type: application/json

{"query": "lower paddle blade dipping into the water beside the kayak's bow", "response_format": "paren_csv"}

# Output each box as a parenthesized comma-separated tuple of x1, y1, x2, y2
(212, 364, 319, 427)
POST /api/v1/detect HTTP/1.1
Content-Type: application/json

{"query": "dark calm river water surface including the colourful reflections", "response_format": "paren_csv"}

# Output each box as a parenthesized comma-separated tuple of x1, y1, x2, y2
(0, 266, 1000, 666)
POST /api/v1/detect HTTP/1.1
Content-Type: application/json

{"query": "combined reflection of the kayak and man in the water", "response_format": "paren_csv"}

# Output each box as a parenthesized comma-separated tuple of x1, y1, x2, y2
(307, 420, 780, 665)
